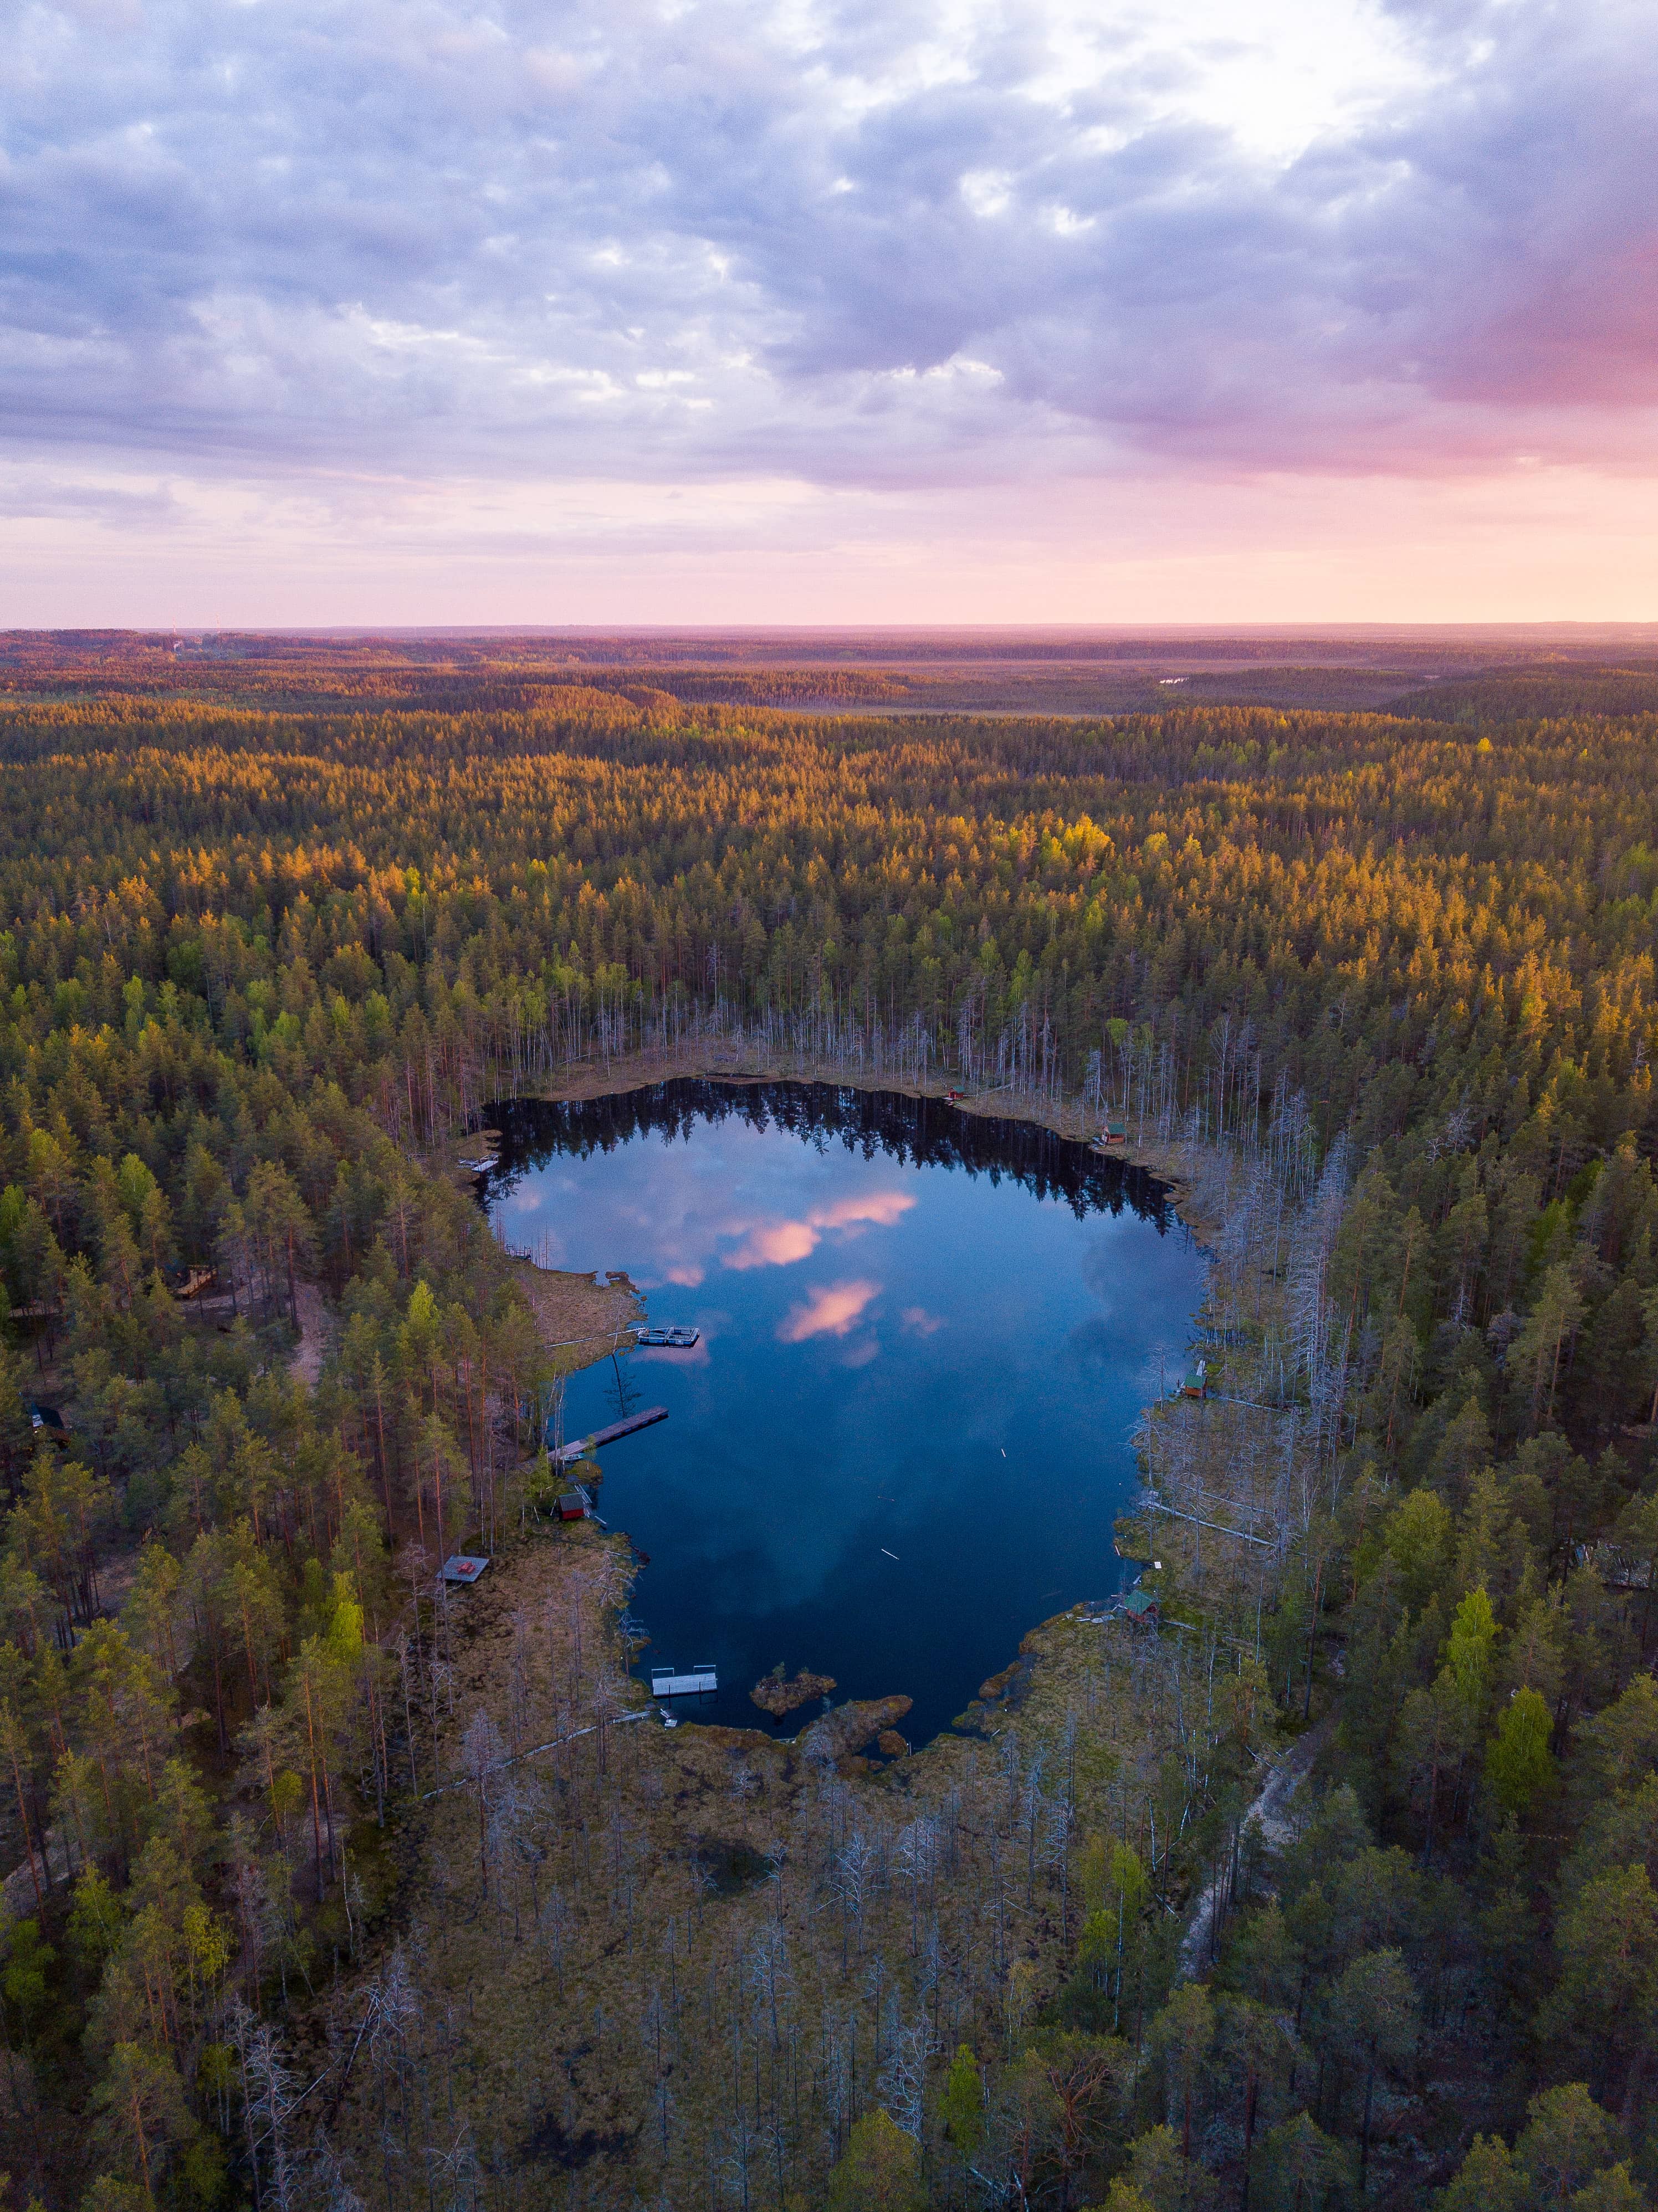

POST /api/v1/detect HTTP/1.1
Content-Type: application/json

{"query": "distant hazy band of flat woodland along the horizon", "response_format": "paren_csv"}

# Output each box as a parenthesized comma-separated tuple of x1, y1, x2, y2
(0, 624, 1656, 721)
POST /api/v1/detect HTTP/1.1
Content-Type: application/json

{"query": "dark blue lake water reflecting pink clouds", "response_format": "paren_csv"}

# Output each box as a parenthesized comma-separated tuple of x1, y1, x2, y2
(487, 1082, 1202, 1741)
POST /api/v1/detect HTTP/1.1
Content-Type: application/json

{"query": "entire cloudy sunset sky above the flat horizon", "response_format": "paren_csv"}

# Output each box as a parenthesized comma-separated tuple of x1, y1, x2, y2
(0, 0, 1658, 626)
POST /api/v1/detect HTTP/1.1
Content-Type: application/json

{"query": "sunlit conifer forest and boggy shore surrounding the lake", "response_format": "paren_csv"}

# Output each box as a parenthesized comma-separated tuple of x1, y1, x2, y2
(0, 646, 1658, 2212)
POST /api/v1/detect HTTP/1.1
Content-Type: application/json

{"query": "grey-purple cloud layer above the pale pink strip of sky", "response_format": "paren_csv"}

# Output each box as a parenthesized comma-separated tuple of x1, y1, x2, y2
(0, 0, 1658, 484)
